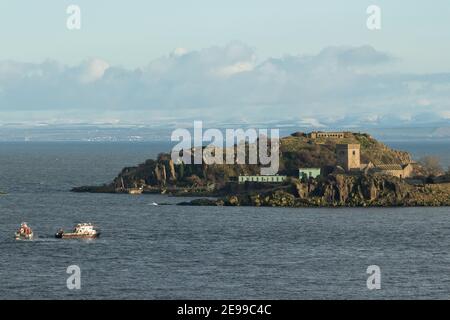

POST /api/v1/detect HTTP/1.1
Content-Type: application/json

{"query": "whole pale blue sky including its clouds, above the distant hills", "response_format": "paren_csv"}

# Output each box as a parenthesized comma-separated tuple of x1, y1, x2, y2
(0, 0, 450, 127)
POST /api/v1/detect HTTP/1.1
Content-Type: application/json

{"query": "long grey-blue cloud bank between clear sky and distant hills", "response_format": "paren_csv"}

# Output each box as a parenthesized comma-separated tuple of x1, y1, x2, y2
(0, 42, 450, 127)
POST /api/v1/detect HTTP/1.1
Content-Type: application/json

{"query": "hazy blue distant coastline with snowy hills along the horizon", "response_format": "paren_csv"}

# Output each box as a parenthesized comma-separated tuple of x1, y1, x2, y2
(0, 123, 450, 142)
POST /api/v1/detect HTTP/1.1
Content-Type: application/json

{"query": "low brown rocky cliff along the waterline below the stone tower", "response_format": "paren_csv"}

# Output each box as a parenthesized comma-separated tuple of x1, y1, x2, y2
(184, 174, 450, 207)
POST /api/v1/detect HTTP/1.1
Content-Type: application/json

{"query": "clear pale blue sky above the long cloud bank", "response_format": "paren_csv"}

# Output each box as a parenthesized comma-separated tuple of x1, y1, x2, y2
(0, 0, 450, 72)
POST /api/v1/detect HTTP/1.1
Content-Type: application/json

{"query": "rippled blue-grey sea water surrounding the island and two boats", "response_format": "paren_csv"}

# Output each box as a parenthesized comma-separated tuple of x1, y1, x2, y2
(0, 142, 450, 299)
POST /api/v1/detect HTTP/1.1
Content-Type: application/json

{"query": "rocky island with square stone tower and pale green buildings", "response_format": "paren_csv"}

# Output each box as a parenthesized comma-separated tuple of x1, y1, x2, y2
(72, 132, 450, 207)
